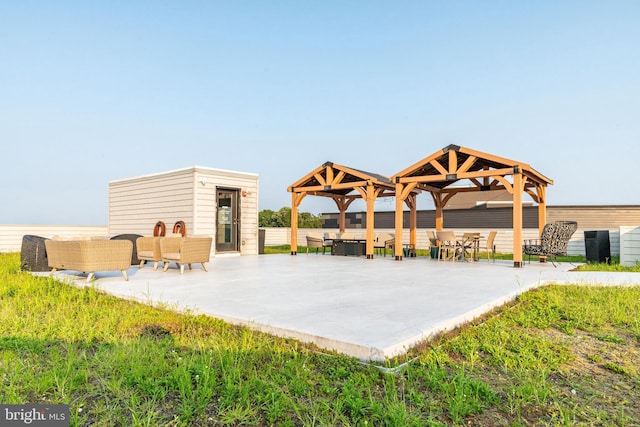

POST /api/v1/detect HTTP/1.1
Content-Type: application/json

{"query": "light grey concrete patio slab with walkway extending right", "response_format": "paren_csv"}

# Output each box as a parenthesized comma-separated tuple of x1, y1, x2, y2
(45, 254, 640, 361)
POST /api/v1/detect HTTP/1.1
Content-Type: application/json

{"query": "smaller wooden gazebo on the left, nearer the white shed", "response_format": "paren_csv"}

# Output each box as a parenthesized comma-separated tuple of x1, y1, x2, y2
(288, 162, 402, 258)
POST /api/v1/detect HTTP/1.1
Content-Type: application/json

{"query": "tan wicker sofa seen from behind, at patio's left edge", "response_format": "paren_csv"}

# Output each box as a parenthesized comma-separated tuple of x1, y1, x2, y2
(44, 239, 133, 282)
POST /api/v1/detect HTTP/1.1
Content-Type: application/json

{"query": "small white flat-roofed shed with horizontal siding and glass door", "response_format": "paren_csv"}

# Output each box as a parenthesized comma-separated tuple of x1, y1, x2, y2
(108, 166, 258, 256)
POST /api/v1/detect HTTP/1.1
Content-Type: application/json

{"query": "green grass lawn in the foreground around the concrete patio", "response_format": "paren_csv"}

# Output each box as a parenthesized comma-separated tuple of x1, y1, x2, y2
(0, 251, 640, 426)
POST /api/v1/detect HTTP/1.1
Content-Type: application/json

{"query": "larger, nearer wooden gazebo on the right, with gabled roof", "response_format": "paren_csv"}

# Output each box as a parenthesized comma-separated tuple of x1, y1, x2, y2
(392, 145, 553, 267)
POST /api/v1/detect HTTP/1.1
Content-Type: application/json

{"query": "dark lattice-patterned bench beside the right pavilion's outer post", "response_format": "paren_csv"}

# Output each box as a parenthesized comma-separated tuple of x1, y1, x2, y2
(522, 221, 578, 267)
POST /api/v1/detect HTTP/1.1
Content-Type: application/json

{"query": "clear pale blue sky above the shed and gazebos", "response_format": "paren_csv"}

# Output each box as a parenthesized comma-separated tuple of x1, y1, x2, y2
(0, 0, 640, 225)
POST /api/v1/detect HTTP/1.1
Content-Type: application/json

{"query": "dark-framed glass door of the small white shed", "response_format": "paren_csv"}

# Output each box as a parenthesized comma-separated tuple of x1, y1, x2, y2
(216, 188, 240, 252)
